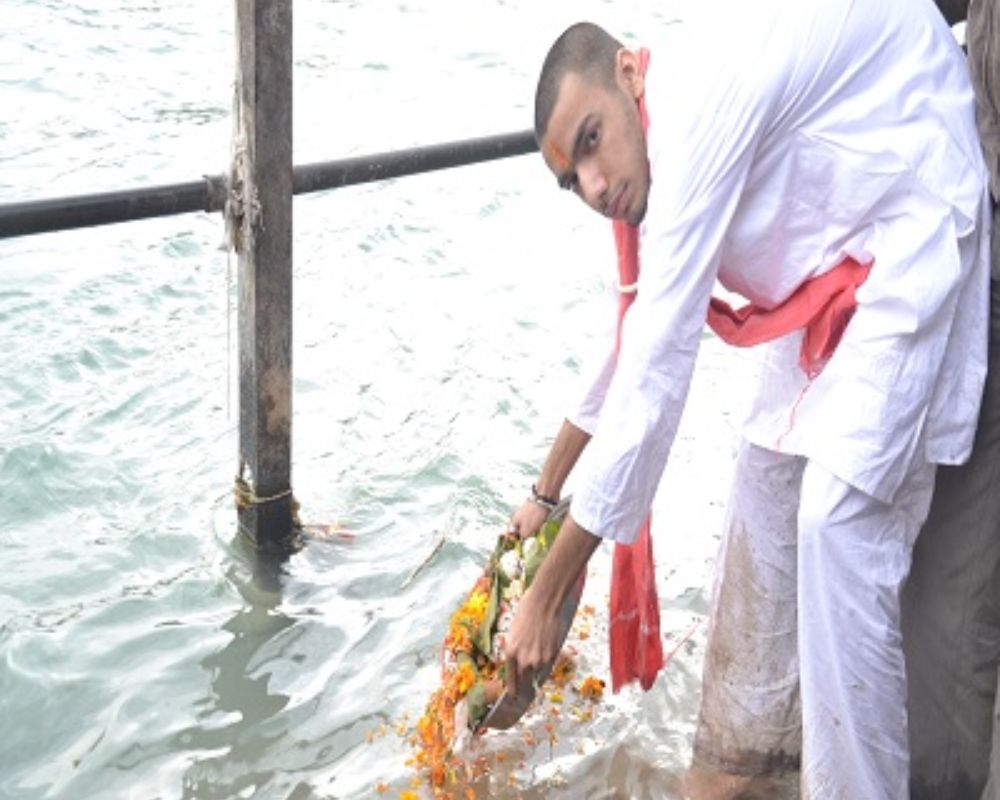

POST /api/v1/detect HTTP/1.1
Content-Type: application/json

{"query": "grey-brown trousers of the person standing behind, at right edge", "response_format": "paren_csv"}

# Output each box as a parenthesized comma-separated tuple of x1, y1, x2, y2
(903, 212, 1000, 800)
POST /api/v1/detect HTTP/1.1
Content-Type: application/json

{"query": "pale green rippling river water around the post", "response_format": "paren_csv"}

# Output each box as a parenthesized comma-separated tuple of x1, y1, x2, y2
(0, 0, 742, 800)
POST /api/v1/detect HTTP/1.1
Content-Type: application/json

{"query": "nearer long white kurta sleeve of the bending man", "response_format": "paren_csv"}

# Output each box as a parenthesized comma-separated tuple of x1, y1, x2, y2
(571, 43, 766, 543)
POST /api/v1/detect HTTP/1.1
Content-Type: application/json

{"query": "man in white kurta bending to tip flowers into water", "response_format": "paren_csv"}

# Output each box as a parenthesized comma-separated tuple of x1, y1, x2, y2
(508, 0, 988, 800)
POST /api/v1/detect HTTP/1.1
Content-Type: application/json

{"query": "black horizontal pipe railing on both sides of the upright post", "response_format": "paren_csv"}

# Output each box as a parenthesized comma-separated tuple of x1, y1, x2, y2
(0, 131, 538, 239)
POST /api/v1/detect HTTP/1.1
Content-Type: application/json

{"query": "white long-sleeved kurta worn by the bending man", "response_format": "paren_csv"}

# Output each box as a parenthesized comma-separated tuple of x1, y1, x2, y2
(569, 0, 988, 542)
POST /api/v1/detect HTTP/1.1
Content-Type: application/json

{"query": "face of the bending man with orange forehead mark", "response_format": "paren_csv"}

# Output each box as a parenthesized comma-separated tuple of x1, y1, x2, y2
(541, 50, 650, 225)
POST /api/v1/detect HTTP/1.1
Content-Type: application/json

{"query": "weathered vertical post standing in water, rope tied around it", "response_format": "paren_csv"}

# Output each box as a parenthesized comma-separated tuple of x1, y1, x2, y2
(232, 0, 294, 550)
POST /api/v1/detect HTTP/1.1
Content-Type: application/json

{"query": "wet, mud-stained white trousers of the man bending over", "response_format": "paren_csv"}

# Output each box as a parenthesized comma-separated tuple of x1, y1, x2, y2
(694, 443, 935, 800)
